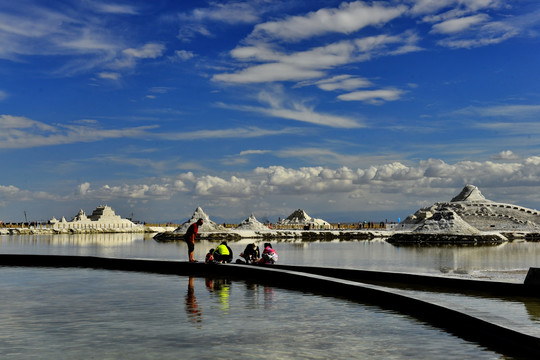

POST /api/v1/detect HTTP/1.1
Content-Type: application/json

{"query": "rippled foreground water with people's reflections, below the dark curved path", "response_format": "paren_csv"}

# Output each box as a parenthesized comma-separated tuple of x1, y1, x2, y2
(0, 268, 502, 359)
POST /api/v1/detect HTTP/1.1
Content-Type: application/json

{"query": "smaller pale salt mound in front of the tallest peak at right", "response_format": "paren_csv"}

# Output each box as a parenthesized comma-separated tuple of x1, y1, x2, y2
(414, 210, 480, 235)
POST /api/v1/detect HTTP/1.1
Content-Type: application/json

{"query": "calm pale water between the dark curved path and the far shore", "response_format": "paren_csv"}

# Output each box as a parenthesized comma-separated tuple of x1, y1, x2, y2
(4, 234, 540, 282)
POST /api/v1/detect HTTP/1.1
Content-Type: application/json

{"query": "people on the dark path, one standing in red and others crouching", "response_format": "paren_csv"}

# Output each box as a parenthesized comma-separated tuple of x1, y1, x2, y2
(184, 219, 278, 264)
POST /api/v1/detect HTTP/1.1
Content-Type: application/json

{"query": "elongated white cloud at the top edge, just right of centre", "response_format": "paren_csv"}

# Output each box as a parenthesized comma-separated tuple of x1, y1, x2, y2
(250, 1, 407, 41)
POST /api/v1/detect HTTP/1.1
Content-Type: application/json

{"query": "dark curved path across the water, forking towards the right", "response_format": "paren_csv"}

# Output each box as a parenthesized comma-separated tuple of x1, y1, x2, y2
(0, 255, 540, 358)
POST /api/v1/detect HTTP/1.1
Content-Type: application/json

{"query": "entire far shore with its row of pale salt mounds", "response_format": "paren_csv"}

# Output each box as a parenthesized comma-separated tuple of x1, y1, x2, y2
(0, 185, 540, 245)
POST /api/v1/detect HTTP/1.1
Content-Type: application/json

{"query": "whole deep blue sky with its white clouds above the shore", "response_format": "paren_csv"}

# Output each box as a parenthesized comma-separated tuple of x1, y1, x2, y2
(0, 0, 540, 222)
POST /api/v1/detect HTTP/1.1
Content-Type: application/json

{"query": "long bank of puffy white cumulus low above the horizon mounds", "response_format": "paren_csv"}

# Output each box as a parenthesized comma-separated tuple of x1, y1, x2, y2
(8, 155, 540, 217)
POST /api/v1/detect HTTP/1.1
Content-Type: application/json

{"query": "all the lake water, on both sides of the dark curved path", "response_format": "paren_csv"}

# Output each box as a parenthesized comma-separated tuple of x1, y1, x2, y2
(0, 234, 540, 359)
